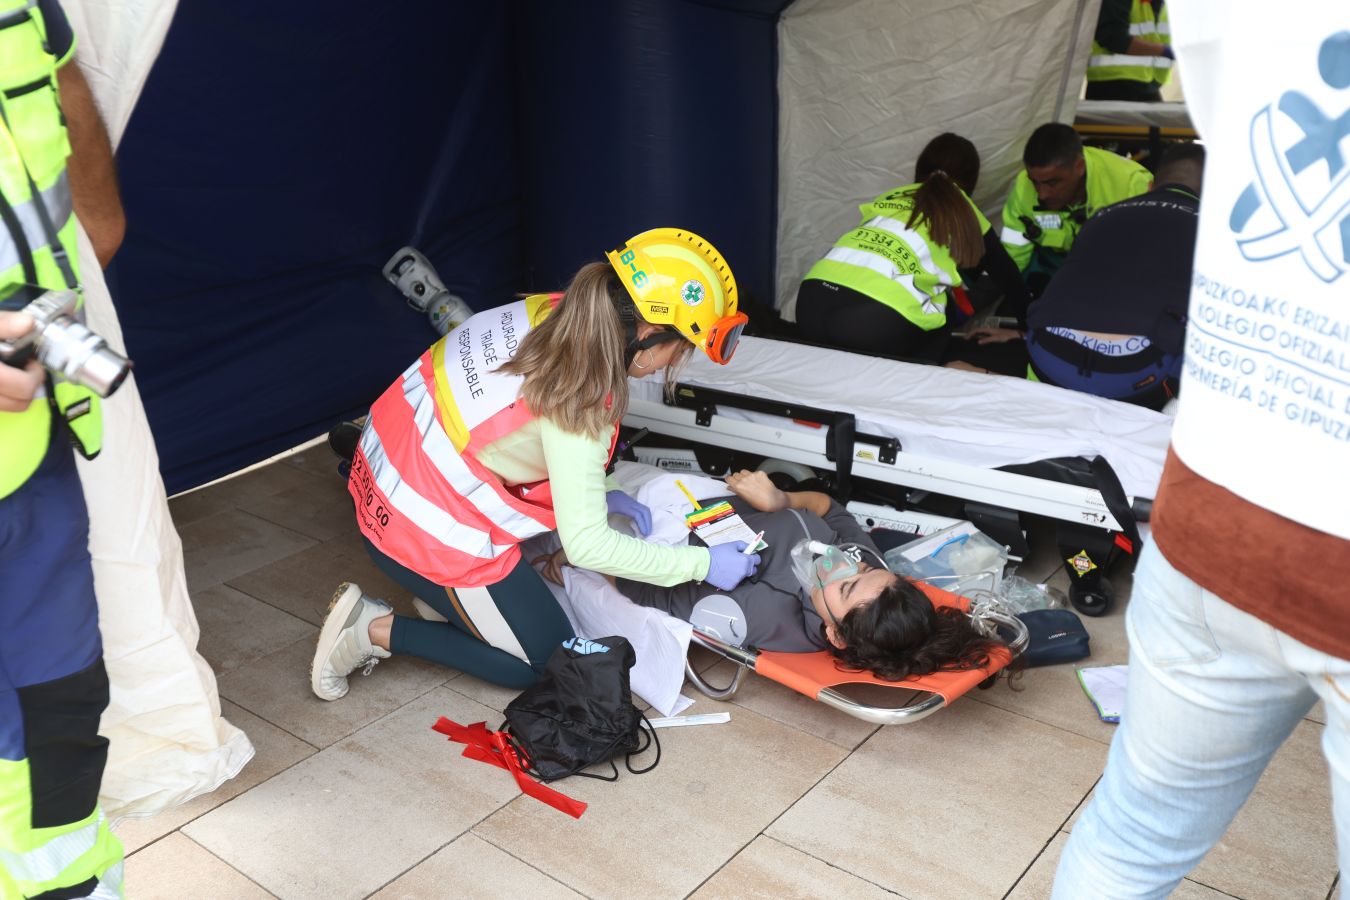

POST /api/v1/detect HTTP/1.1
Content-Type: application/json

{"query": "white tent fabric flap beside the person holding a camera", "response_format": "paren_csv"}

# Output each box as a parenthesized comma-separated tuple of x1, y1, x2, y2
(63, 0, 254, 819)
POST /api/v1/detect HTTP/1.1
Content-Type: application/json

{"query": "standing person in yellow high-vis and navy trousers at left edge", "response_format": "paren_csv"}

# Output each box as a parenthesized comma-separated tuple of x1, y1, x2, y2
(0, 0, 123, 900)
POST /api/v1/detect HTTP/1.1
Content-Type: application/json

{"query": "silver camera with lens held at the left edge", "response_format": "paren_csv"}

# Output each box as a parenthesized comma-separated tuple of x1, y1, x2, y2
(0, 286, 131, 397)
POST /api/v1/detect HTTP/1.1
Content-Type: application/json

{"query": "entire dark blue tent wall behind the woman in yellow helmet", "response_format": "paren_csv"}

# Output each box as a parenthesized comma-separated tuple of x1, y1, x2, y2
(109, 0, 786, 493)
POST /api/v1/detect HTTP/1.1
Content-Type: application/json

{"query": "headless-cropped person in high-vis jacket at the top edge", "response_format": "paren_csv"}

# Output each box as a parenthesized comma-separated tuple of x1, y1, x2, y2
(1087, 0, 1176, 103)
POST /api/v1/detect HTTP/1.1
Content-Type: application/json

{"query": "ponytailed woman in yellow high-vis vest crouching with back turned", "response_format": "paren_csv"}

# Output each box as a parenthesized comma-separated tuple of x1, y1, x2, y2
(797, 132, 1029, 360)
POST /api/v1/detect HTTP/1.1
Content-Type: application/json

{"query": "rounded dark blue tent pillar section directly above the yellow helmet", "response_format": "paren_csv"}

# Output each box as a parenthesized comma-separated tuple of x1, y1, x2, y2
(510, 0, 787, 304)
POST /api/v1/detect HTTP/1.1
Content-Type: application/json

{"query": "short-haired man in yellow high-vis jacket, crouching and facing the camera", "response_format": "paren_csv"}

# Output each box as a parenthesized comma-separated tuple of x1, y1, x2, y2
(1002, 121, 1153, 297)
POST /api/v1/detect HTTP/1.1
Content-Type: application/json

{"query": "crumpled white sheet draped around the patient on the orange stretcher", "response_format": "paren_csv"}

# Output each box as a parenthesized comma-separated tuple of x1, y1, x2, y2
(524, 461, 728, 715)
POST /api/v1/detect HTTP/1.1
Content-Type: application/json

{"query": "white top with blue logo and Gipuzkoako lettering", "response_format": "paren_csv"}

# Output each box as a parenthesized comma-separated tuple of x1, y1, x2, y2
(1169, 7, 1350, 538)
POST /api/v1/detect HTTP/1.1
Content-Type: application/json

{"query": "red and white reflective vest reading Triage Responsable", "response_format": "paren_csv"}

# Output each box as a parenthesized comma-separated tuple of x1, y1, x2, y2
(347, 294, 596, 587)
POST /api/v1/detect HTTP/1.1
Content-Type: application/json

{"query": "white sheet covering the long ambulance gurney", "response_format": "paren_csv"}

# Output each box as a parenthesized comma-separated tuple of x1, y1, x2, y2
(629, 337, 1172, 498)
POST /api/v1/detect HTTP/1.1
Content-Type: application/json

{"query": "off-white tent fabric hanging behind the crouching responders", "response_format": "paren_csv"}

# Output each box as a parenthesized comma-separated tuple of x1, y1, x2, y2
(775, 0, 1100, 320)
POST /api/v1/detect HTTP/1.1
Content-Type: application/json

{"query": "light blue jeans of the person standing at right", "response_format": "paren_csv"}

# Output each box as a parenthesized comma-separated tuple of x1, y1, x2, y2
(1054, 544, 1350, 900)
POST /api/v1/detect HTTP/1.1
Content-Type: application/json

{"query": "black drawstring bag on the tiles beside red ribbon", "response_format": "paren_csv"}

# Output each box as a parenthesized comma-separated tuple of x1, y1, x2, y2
(502, 637, 662, 781)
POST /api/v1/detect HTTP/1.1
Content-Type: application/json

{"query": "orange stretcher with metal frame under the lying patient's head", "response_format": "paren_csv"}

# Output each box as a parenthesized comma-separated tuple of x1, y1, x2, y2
(684, 582, 1027, 725)
